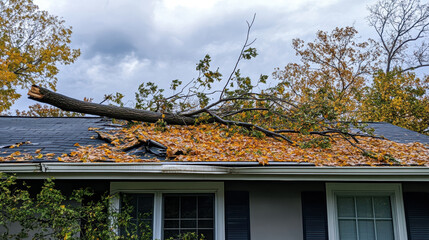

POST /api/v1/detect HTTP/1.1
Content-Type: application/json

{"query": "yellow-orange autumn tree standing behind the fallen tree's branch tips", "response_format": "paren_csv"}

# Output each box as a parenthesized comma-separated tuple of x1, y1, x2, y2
(273, 27, 379, 128)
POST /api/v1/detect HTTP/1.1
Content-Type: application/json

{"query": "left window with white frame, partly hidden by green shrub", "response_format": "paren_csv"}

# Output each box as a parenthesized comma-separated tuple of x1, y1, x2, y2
(111, 182, 224, 240)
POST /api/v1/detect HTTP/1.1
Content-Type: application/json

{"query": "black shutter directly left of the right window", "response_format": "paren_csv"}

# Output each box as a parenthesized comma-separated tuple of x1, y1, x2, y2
(301, 192, 328, 240)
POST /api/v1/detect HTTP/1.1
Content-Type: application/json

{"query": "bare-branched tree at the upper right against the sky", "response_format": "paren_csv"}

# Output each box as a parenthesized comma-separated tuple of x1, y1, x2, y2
(368, 0, 429, 73)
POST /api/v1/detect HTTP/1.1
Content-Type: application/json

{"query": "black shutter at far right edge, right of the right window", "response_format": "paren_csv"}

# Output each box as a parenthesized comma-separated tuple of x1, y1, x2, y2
(404, 192, 429, 240)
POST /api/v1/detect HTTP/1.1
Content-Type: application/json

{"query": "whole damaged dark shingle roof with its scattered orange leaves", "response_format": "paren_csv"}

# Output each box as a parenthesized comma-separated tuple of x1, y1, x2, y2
(0, 117, 429, 166)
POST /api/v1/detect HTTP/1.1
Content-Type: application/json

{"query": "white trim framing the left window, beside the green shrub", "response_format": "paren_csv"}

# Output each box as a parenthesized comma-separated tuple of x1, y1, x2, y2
(110, 182, 225, 240)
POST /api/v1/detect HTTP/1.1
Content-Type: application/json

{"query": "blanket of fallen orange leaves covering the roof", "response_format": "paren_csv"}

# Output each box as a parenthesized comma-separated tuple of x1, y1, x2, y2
(0, 124, 429, 166)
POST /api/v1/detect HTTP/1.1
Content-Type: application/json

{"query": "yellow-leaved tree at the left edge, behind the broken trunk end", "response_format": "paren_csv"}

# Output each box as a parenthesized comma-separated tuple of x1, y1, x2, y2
(0, 0, 80, 112)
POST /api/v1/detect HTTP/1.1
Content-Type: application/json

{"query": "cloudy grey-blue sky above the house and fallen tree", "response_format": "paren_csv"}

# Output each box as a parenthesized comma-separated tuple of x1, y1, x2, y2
(13, 0, 375, 109)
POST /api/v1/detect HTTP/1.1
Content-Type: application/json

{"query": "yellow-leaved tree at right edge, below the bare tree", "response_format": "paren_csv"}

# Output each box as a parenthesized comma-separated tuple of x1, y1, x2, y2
(361, 70, 429, 132)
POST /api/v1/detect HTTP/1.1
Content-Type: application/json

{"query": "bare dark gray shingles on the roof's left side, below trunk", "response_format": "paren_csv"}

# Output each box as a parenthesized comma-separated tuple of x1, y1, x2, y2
(0, 117, 110, 156)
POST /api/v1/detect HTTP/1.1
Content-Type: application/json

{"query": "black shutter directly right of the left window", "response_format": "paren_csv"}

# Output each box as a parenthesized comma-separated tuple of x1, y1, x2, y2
(225, 191, 250, 240)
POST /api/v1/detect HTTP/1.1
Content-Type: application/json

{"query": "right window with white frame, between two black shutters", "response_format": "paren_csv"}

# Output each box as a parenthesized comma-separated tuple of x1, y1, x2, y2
(326, 183, 407, 240)
